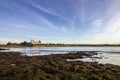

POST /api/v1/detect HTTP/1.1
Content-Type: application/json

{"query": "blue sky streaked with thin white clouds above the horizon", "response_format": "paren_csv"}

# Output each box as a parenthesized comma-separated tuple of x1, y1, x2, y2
(0, 0, 120, 44)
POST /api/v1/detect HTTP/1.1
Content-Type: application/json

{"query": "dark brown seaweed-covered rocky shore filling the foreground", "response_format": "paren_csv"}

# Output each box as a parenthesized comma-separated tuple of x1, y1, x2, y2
(0, 52, 120, 80)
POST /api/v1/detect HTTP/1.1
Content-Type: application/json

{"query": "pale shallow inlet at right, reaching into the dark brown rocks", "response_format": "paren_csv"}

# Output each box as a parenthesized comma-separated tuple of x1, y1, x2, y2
(67, 52, 120, 65)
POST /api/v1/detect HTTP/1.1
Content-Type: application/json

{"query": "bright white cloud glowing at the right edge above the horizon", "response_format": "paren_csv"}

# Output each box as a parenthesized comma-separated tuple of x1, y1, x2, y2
(91, 13, 120, 43)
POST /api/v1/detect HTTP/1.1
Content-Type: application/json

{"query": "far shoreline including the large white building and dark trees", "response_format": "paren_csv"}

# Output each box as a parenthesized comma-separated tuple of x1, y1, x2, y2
(0, 39, 120, 48)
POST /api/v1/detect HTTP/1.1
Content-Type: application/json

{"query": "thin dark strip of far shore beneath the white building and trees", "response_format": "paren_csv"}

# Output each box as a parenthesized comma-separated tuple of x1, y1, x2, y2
(0, 43, 120, 48)
